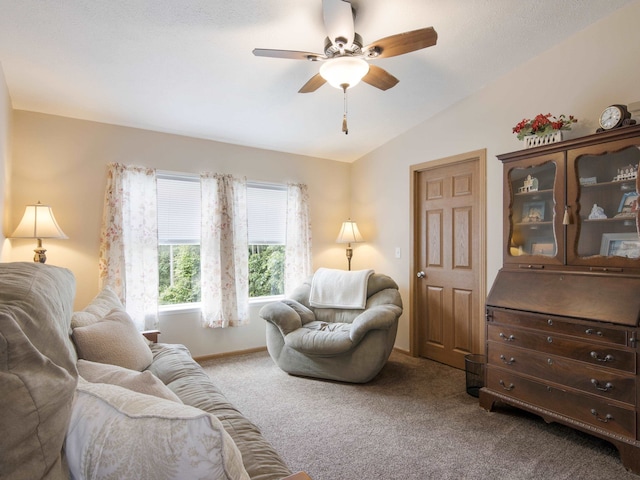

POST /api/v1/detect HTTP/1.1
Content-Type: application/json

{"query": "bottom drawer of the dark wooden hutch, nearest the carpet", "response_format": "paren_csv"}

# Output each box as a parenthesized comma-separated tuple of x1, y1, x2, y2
(487, 365, 636, 439)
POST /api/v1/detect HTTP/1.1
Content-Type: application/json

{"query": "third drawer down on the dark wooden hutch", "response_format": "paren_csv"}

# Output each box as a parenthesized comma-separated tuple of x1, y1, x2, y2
(488, 342, 636, 407)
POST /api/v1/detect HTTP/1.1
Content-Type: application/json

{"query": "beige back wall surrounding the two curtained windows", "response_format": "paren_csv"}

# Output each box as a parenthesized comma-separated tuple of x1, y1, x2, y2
(7, 111, 350, 356)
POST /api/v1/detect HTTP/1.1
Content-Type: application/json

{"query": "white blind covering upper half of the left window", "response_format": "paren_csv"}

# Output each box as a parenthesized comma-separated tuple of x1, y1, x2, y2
(157, 174, 200, 245)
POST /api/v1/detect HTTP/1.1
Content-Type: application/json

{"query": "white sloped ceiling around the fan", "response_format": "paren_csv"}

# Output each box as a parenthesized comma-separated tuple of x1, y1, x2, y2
(0, 0, 633, 161)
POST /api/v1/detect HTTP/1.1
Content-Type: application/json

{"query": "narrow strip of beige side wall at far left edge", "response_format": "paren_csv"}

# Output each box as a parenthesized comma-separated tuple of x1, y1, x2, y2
(0, 64, 12, 261)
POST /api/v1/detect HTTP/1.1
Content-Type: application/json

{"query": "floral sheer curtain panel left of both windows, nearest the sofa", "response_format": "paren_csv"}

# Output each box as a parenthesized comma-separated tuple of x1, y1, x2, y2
(99, 163, 158, 330)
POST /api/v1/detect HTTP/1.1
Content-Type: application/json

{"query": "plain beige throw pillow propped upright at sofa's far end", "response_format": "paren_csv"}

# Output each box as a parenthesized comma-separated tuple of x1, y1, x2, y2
(72, 309, 153, 372)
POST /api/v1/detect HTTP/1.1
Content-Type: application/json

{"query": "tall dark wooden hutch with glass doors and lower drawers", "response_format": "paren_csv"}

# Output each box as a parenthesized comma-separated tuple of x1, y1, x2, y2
(480, 126, 640, 473)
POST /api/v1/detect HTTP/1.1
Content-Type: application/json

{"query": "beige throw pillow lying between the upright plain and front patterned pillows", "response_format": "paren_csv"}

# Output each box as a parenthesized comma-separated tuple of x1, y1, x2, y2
(77, 359, 182, 403)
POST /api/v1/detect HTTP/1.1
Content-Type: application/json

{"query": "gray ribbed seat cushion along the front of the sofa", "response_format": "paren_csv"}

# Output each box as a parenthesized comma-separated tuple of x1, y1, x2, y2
(149, 344, 291, 480)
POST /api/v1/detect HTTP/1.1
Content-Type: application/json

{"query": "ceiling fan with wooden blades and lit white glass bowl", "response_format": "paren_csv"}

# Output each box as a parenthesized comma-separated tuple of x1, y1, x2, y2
(253, 0, 438, 133)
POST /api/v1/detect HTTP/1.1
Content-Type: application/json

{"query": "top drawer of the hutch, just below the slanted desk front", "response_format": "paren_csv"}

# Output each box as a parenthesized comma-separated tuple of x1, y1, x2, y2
(490, 309, 629, 346)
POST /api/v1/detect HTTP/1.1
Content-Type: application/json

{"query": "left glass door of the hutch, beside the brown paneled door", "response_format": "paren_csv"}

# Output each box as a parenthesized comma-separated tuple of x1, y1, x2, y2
(504, 153, 565, 264)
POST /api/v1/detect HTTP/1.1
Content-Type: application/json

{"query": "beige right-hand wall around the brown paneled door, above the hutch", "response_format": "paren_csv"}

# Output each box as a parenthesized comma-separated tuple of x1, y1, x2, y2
(351, 2, 640, 350)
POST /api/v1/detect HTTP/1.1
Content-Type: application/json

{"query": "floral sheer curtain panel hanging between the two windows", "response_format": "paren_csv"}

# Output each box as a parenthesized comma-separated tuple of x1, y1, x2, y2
(200, 173, 249, 328)
